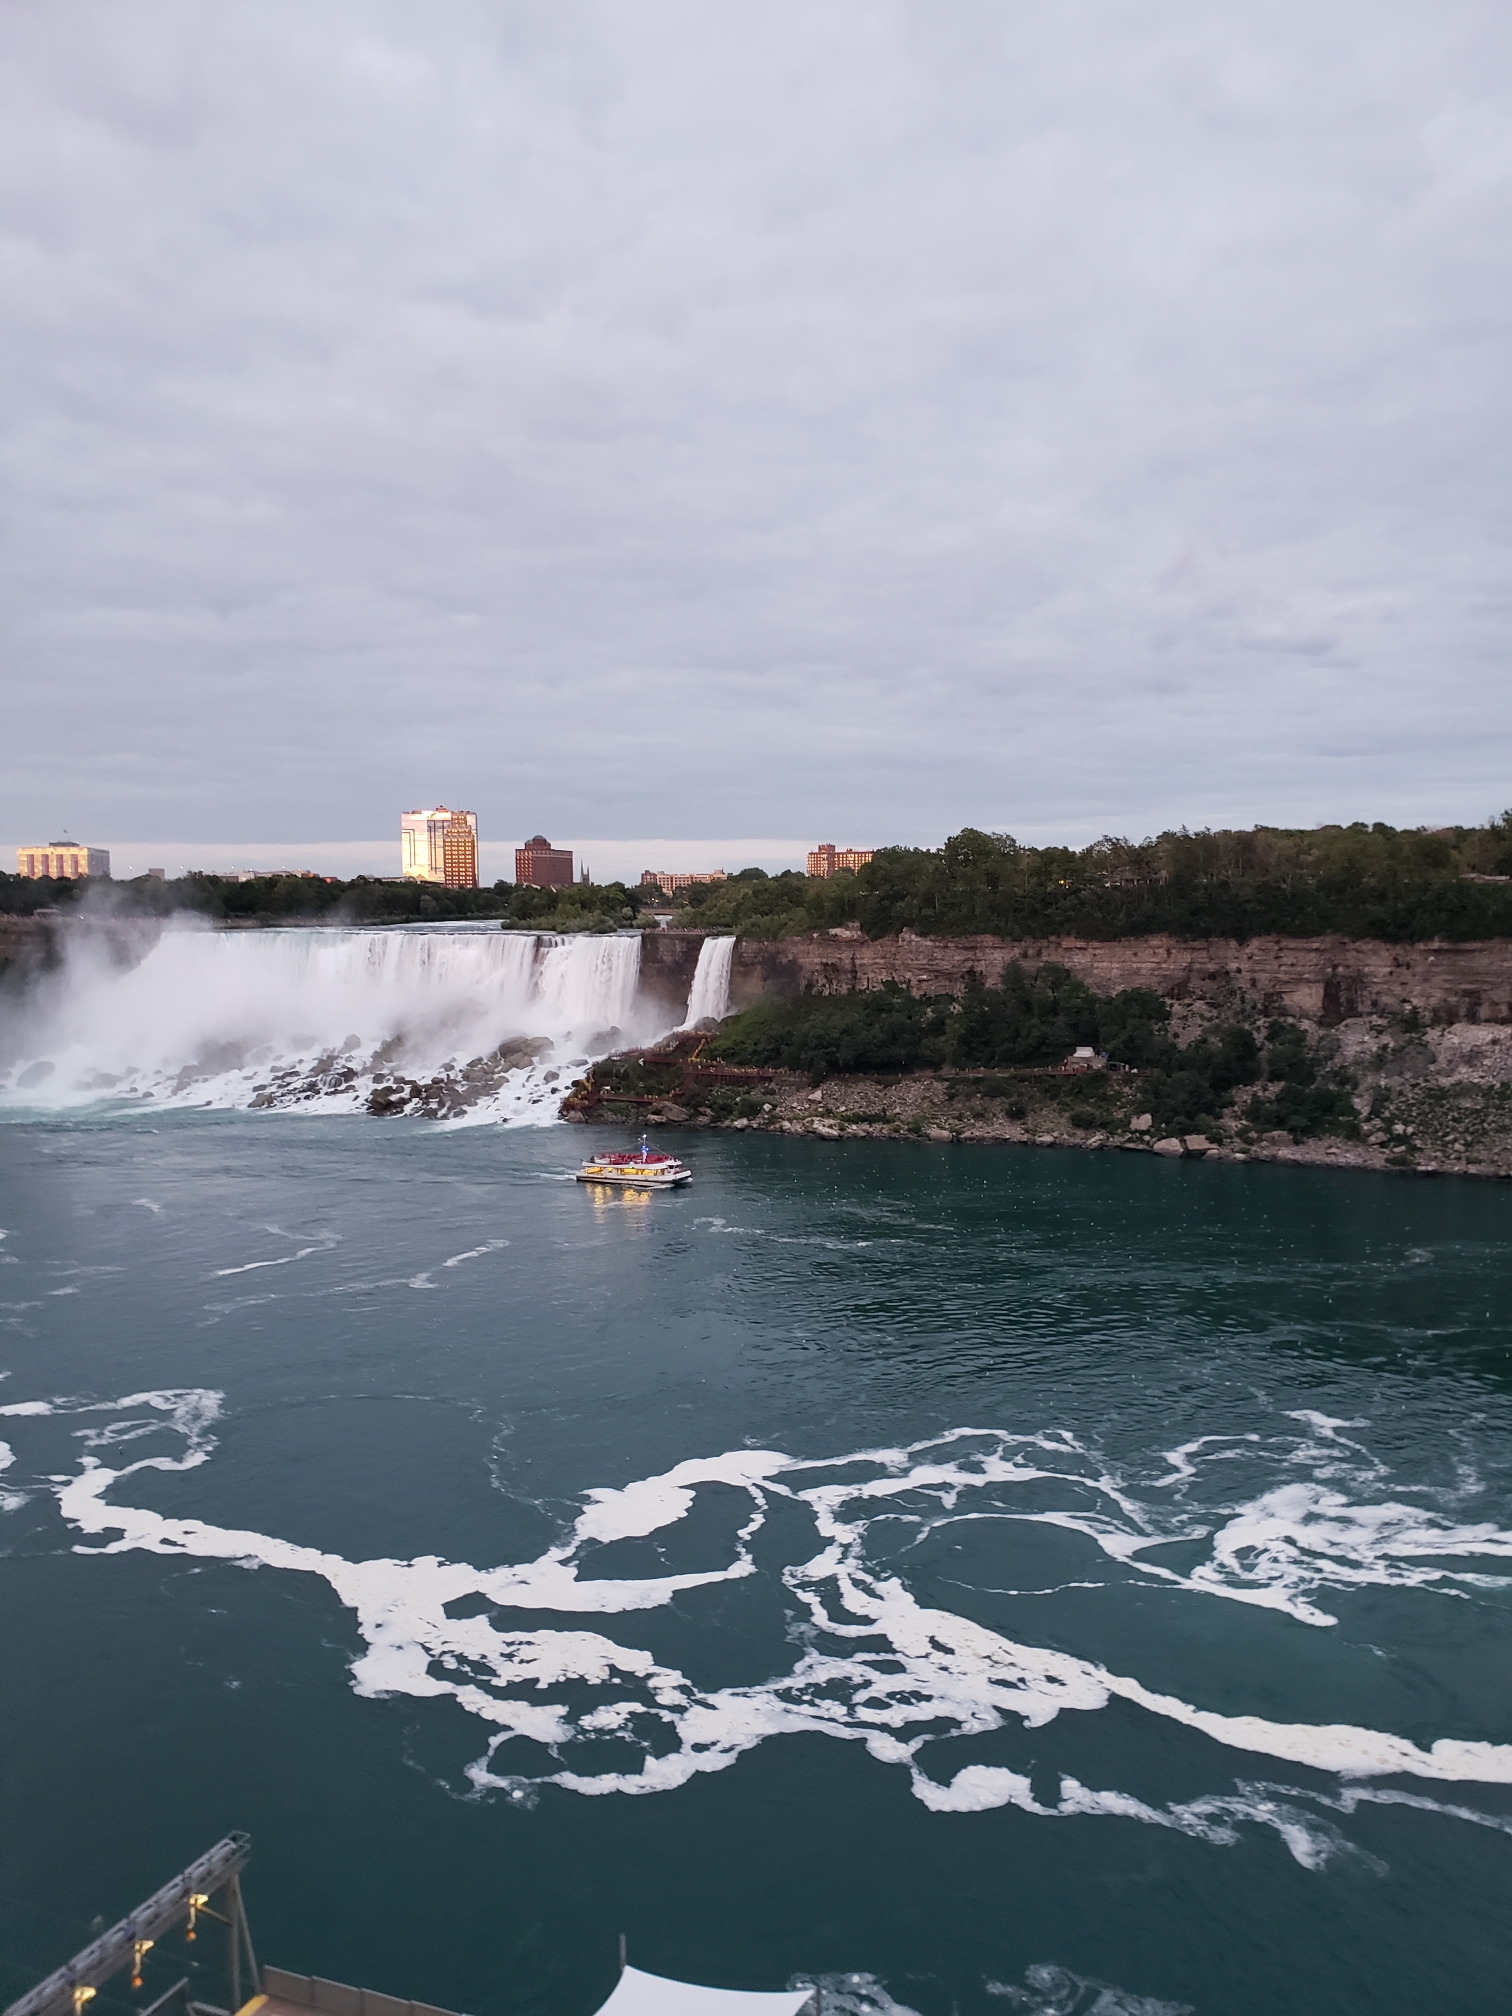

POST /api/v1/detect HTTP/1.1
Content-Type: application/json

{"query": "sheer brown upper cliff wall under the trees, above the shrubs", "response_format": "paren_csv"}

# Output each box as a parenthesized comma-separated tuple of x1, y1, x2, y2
(717, 931, 1512, 1028)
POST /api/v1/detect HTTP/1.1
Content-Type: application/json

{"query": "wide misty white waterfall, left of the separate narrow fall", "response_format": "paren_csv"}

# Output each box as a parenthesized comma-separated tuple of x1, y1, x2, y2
(0, 929, 667, 1121)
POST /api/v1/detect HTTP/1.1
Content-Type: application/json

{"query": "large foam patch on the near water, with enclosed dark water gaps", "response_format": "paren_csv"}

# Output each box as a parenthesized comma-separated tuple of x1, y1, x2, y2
(0, 1389, 1512, 1869)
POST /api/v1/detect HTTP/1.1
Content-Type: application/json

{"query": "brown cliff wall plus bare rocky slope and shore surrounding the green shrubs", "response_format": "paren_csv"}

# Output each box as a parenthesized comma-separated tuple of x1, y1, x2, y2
(643, 931, 1512, 1177)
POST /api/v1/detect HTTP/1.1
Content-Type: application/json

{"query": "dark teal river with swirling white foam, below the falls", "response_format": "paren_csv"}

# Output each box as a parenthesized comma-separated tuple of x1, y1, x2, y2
(0, 1113, 1512, 2016)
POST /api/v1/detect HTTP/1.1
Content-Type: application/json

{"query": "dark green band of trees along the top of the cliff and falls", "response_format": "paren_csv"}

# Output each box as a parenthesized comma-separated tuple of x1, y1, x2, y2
(0, 810, 1512, 943)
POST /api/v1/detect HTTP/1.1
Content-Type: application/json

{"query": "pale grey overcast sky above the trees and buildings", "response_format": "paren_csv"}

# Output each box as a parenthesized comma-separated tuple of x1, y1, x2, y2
(0, 0, 1512, 845)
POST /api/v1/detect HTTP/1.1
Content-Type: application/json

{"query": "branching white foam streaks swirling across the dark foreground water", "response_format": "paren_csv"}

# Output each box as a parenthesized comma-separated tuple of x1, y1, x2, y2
(11, 1395, 1512, 1869)
